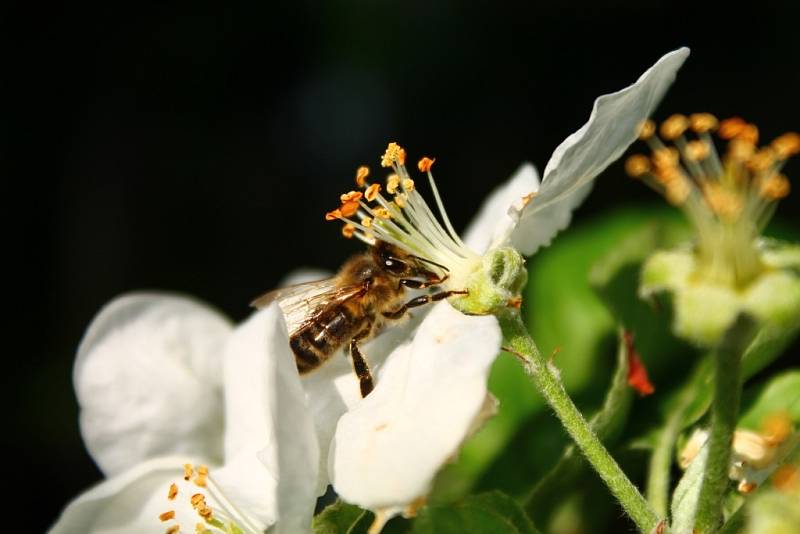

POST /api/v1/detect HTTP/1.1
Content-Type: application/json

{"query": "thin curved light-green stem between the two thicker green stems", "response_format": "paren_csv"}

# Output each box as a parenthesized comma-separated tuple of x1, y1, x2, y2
(646, 360, 710, 517)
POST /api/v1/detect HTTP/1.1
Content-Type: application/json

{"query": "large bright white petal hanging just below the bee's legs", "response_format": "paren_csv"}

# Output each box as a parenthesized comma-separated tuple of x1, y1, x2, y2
(330, 302, 501, 513)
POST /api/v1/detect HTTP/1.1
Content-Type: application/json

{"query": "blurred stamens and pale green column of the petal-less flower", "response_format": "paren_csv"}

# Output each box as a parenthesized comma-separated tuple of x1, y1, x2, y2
(625, 113, 800, 287)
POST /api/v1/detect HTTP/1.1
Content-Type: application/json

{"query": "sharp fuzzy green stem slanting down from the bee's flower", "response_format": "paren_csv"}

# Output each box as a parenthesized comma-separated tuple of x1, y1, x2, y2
(498, 310, 659, 532)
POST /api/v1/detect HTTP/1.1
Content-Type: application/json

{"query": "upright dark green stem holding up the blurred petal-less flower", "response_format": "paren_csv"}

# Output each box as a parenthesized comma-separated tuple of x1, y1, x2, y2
(695, 315, 755, 534)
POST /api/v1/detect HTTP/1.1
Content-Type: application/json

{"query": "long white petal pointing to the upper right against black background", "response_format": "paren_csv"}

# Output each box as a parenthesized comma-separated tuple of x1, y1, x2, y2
(511, 48, 689, 255)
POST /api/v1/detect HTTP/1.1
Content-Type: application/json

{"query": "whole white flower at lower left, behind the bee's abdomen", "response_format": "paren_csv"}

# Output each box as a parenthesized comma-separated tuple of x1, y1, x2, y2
(51, 295, 318, 533)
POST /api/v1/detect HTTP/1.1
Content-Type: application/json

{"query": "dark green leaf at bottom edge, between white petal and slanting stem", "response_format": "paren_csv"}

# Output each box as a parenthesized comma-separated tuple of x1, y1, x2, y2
(411, 491, 536, 534)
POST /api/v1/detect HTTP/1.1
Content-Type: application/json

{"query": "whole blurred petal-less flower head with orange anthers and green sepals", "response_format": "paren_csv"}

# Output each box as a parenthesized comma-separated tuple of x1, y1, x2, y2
(626, 113, 800, 346)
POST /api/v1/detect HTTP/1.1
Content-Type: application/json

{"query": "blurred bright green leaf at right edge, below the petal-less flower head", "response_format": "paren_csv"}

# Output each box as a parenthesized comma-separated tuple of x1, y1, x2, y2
(739, 369, 800, 430)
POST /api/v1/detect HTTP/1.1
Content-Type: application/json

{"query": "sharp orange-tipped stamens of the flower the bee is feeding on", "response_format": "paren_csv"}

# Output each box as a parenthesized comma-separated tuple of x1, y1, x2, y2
(325, 143, 480, 289)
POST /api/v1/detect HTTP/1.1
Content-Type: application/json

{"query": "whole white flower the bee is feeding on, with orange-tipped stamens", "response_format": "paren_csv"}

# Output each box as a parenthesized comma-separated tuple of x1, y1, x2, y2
(304, 48, 689, 521)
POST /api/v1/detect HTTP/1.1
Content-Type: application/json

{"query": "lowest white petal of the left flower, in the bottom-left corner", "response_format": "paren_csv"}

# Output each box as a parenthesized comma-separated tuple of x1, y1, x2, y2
(49, 457, 211, 534)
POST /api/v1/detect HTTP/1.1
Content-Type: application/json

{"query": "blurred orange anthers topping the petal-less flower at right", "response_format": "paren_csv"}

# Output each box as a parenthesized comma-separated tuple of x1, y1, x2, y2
(625, 113, 800, 224)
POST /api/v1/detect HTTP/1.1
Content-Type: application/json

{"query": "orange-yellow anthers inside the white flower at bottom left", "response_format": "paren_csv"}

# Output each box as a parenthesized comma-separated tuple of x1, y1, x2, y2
(158, 464, 253, 534)
